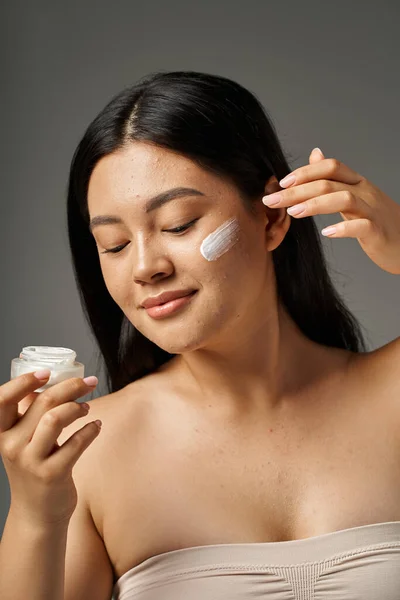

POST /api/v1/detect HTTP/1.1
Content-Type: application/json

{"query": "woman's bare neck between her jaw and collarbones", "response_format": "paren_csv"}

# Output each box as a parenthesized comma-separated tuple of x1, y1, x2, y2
(169, 304, 344, 416)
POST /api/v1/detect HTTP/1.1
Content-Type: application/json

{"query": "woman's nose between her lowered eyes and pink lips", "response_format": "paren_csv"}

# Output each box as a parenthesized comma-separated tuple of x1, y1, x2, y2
(132, 236, 174, 284)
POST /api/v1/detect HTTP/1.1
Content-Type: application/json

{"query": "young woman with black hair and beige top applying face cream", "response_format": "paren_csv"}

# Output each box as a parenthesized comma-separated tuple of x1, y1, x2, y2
(3, 72, 400, 600)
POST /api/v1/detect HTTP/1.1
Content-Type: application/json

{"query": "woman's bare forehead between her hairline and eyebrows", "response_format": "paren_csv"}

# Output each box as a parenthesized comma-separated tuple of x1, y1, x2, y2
(88, 142, 227, 213)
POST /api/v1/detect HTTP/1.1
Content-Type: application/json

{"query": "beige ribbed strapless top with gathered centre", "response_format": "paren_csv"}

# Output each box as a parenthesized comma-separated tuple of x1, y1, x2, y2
(113, 521, 400, 600)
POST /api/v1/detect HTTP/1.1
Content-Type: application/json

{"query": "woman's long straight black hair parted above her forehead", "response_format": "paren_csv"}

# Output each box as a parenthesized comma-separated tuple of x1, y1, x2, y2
(67, 71, 366, 393)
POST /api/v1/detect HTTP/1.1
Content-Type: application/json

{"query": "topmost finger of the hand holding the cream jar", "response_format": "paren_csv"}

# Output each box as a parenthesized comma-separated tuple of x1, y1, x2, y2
(0, 373, 50, 433)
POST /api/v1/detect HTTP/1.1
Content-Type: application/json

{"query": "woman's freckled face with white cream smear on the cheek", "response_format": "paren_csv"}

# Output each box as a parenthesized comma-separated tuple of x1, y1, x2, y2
(88, 142, 287, 354)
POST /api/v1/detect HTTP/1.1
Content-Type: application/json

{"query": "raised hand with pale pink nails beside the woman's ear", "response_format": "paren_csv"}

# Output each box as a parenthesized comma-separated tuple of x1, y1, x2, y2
(263, 148, 400, 275)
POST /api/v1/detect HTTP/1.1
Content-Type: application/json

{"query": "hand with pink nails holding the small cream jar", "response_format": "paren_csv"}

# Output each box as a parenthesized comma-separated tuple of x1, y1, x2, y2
(0, 373, 100, 526)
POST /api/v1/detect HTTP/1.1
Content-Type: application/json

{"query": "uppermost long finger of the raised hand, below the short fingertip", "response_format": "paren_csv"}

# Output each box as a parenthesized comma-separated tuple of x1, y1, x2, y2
(279, 158, 364, 187)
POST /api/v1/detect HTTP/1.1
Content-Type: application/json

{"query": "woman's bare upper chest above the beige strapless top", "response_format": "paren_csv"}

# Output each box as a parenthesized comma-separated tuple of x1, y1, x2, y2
(93, 392, 400, 577)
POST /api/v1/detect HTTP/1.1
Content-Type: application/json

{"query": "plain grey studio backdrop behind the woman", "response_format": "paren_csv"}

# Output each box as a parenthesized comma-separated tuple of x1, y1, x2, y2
(0, 0, 400, 544)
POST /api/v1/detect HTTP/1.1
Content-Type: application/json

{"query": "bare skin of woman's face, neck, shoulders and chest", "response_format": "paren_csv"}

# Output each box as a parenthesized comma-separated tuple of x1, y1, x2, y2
(58, 143, 400, 579)
